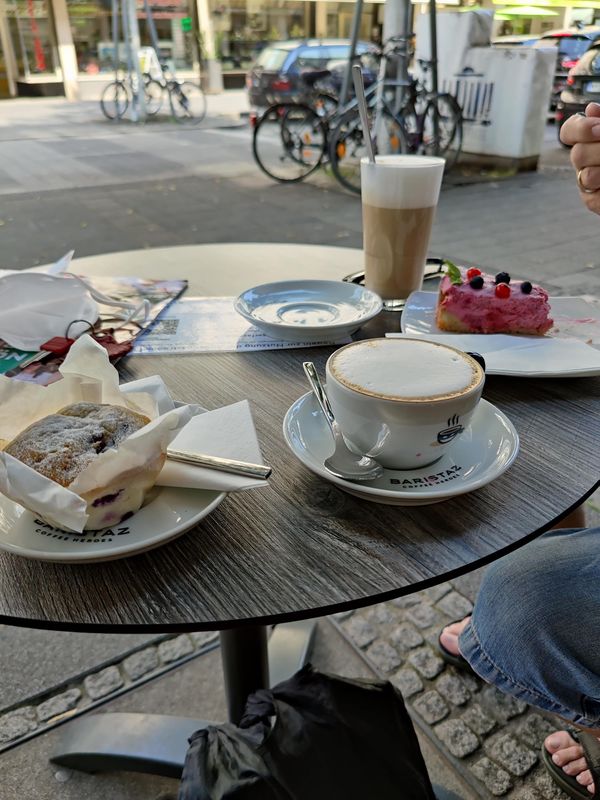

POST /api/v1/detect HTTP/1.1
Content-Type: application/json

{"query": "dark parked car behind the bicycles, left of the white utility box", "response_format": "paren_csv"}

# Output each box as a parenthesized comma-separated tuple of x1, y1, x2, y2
(246, 39, 377, 108)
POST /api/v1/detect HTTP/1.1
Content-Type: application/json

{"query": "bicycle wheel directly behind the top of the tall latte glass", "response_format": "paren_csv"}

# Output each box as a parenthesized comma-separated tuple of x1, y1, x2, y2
(329, 110, 409, 194)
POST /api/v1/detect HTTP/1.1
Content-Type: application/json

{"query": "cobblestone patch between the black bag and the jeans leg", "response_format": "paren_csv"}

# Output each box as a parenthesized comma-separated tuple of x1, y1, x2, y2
(341, 571, 567, 800)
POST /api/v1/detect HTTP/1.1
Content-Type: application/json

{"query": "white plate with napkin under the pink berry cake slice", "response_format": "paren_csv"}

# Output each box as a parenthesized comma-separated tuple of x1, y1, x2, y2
(401, 292, 600, 378)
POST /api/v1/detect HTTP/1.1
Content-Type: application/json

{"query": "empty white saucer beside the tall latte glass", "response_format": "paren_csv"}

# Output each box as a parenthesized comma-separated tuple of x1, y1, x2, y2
(234, 281, 382, 342)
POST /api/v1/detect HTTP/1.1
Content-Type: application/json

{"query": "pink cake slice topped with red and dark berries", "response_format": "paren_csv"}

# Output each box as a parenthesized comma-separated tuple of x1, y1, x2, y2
(436, 262, 553, 336)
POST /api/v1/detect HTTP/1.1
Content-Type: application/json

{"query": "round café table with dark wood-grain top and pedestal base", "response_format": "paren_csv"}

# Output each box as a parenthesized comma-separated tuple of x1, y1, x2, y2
(0, 244, 600, 775)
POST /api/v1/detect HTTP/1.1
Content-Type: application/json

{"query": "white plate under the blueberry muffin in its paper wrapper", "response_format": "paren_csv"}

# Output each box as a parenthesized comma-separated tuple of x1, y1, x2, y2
(0, 486, 226, 564)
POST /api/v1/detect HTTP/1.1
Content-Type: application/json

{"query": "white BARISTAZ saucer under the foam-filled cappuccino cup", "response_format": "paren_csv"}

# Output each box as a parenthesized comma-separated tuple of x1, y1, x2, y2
(283, 392, 519, 506)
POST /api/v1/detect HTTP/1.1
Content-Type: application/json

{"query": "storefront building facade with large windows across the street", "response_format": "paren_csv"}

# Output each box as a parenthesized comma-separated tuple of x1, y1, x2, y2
(0, 0, 600, 99)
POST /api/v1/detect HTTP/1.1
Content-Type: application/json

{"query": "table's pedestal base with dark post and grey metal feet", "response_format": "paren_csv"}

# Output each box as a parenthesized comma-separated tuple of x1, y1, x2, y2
(50, 620, 316, 778)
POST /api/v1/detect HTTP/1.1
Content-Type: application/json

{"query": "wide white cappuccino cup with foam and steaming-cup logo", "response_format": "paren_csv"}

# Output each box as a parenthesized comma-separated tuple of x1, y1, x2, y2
(326, 339, 485, 469)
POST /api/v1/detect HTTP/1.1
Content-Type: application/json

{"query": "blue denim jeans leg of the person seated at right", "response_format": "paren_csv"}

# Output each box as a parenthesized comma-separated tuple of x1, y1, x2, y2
(459, 528, 600, 728)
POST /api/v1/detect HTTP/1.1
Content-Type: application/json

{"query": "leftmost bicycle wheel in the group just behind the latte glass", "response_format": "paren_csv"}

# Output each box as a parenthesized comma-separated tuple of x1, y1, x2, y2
(252, 103, 327, 183)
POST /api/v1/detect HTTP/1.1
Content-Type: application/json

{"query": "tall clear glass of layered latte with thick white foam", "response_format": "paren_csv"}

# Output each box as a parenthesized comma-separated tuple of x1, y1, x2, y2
(360, 156, 445, 311)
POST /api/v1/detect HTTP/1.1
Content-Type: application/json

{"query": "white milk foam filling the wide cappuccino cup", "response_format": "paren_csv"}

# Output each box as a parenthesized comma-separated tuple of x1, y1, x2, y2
(330, 339, 483, 401)
